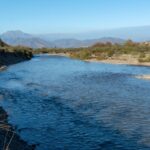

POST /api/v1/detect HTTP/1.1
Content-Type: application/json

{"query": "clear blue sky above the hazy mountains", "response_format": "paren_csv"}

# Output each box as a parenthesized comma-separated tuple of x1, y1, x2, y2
(0, 0, 150, 33)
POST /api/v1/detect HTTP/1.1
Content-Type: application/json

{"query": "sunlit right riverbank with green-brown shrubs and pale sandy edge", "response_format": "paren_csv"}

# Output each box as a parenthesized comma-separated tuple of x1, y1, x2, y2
(33, 40, 150, 66)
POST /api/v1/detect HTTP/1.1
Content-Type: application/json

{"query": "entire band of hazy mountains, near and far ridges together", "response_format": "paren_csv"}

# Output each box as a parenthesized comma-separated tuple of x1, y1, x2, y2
(0, 26, 150, 48)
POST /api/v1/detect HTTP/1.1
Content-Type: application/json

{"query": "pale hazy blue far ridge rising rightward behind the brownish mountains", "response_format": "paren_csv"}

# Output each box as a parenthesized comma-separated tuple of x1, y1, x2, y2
(36, 26, 150, 42)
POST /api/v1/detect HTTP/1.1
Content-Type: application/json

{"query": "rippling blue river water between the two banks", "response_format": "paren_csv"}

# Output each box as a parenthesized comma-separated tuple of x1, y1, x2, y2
(0, 55, 150, 150)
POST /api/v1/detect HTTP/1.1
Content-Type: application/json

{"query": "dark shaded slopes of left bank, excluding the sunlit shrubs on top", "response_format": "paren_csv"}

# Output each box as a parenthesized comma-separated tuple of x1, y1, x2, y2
(0, 52, 36, 150)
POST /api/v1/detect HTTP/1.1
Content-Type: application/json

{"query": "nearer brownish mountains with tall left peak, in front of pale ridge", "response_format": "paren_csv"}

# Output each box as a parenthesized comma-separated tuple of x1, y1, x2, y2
(0, 31, 124, 48)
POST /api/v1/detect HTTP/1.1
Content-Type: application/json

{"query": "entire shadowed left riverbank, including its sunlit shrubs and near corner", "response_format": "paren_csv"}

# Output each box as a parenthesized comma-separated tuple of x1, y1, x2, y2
(0, 42, 35, 150)
